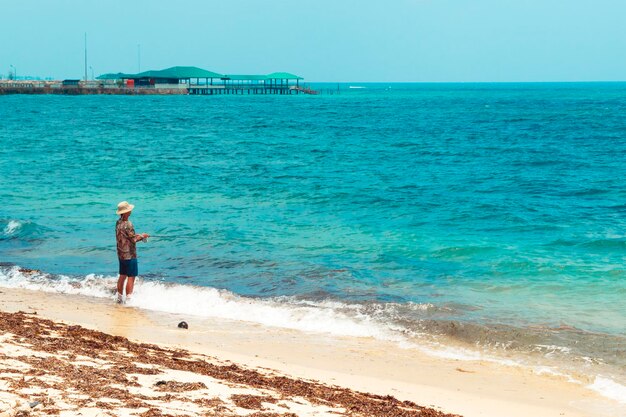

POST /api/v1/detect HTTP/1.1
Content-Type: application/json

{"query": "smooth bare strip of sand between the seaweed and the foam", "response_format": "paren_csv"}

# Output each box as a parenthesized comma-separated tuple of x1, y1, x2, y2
(0, 288, 623, 417)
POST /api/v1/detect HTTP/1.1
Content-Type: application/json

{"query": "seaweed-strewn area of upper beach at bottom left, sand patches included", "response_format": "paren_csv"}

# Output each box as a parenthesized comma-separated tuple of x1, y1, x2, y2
(0, 312, 459, 417)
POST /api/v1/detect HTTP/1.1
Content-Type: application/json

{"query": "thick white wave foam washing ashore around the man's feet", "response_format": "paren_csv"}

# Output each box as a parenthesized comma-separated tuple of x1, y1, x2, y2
(0, 267, 403, 341)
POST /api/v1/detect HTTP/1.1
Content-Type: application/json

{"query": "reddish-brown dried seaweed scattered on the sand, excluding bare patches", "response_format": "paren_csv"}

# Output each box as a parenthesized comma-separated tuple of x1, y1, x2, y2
(0, 312, 458, 417)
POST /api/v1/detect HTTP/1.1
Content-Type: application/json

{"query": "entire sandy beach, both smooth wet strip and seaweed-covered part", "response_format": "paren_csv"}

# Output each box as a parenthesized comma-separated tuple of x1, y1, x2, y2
(0, 288, 622, 417)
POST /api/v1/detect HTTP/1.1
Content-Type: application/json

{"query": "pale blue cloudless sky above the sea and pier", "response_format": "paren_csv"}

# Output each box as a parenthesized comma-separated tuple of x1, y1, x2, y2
(0, 0, 626, 82)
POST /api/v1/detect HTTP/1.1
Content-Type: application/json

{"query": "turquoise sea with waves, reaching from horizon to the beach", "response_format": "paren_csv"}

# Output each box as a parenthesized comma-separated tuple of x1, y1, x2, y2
(0, 83, 626, 402)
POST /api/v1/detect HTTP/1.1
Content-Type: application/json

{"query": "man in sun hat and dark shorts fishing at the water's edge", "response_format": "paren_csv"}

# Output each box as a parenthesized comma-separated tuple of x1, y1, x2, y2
(115, 201, 150, 303)
